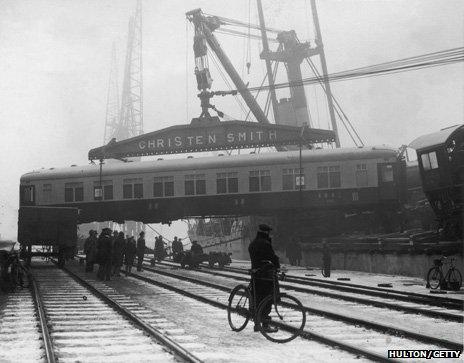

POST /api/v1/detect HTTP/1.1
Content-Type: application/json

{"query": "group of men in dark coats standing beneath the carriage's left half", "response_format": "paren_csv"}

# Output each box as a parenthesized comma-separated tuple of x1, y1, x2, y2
(84, 228, 145, 281)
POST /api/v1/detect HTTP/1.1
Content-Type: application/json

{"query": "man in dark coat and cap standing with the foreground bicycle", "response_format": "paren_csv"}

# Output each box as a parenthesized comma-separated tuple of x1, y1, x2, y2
(248, 224, 280, 333)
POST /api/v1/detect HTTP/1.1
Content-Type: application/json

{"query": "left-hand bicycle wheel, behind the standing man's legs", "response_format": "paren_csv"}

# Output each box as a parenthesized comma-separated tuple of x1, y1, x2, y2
(227, 285, 251, 331)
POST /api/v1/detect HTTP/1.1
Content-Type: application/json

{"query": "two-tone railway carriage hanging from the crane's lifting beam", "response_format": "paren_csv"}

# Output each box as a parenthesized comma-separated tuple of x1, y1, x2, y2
(20, 147, 405, 235)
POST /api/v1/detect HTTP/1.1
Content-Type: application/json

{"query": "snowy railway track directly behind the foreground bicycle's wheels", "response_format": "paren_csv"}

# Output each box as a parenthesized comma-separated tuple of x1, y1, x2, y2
(131, 267, 462, 361)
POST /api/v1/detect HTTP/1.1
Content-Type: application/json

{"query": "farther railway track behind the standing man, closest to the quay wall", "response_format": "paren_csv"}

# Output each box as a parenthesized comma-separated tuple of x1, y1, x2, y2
(154, 262, 464, 323)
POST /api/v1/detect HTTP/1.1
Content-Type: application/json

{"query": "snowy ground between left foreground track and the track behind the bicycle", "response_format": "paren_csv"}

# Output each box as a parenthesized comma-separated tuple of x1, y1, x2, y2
(103, 273, 372, 363)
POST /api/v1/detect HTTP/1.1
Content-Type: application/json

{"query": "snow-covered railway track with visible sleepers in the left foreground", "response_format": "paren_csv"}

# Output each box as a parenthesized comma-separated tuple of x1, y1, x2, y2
(28, 266, 200, 362)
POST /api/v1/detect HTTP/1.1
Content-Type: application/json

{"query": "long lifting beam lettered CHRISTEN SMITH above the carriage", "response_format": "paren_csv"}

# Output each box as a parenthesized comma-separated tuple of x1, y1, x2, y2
(89, 121, 334, 160)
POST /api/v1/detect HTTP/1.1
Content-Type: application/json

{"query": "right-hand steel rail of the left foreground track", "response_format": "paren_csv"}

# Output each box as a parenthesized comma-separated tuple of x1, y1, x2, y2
(54, 261, 202, 363)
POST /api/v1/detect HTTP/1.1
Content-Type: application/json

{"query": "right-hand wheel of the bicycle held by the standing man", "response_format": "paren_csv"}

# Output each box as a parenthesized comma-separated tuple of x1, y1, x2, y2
(257, 294, 306, 343)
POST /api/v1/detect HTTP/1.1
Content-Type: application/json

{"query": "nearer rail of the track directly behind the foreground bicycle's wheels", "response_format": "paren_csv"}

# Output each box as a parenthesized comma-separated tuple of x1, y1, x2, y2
(128, 268, 397, 362)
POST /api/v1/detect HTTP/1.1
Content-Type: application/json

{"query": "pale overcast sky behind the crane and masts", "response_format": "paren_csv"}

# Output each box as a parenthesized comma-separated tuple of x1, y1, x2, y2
(0, 0, 464, 242)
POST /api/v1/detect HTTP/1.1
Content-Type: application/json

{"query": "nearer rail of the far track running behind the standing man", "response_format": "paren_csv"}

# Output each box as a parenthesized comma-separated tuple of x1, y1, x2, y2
(157, 260, 464, 323)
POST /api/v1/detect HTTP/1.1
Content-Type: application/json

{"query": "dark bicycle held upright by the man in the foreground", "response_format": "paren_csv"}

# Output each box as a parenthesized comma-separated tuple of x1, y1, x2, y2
(227, 262, 306, 343)
